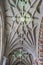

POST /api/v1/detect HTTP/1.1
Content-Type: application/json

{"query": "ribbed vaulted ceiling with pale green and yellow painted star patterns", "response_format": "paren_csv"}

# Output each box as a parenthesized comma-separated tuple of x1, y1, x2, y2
(0, 0, 42, 65)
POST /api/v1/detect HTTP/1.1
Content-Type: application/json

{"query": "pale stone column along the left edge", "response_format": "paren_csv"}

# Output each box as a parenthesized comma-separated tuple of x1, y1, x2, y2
(0, 2, 5, 65)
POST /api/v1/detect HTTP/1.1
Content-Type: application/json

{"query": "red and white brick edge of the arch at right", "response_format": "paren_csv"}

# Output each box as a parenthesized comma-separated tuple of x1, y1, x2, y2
(39, 18, 43, 65)
